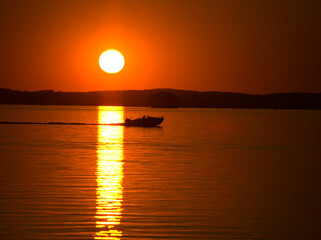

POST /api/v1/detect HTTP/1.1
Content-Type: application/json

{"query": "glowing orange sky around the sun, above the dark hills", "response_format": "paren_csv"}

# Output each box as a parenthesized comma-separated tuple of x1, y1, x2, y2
(0, 0, 321, 93)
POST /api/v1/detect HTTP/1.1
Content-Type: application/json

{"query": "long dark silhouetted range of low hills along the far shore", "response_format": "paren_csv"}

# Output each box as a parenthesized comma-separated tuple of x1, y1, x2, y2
(0, 88, 321, 109)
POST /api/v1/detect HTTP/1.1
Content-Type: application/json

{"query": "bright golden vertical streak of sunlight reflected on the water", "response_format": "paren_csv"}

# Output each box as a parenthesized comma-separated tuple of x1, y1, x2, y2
(95, 106, 124, 240)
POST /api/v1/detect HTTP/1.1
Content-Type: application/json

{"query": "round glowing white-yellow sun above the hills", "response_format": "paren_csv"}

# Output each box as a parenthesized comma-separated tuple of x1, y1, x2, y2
(99, 49, 125, 73)
